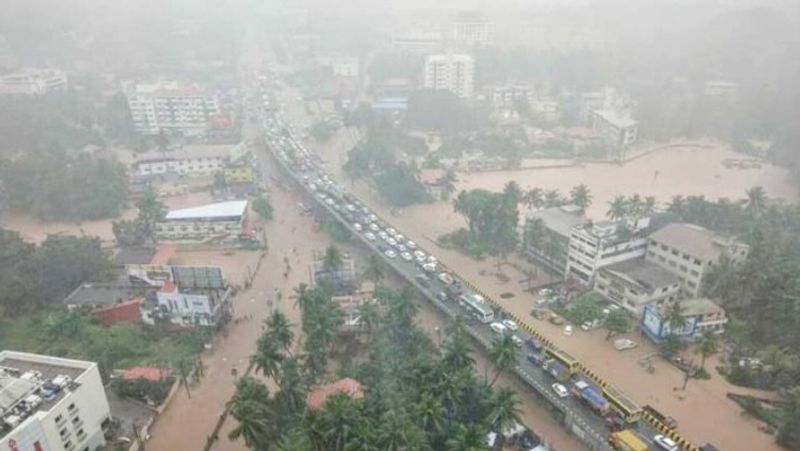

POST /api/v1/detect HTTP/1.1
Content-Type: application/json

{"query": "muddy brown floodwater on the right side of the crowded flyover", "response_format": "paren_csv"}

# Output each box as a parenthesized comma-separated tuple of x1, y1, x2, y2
(272, 86, 797, 450)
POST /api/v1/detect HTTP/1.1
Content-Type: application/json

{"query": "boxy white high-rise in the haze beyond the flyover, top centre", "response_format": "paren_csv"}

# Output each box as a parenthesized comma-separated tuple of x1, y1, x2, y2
(424, 54, 475, 98)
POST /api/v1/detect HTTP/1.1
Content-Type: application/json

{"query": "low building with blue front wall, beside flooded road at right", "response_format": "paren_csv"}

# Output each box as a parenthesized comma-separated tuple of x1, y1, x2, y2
(639, 298, 728, 343)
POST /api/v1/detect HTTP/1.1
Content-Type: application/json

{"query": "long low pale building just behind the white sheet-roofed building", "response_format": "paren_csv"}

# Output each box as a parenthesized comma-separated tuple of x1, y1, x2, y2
(134, 145, 234, 176)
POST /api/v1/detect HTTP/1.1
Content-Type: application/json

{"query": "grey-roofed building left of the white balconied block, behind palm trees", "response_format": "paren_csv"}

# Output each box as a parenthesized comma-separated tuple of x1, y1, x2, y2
(522, 205, 589, 274)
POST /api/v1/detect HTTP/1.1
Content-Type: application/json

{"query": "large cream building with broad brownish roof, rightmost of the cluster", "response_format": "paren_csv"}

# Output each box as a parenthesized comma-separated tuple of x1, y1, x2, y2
(646, 223, 749, 297)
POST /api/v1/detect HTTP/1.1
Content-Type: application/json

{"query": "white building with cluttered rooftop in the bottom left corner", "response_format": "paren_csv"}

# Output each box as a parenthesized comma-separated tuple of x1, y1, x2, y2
(0, 351, 111, 451)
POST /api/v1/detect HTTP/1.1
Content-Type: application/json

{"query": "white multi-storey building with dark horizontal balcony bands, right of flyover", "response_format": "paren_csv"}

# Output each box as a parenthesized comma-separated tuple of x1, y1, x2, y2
(565, 220, 649, 286)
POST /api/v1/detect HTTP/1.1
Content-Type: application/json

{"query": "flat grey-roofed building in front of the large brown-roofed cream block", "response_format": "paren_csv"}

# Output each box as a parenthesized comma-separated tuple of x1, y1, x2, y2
(594, 258, 681, 318)
